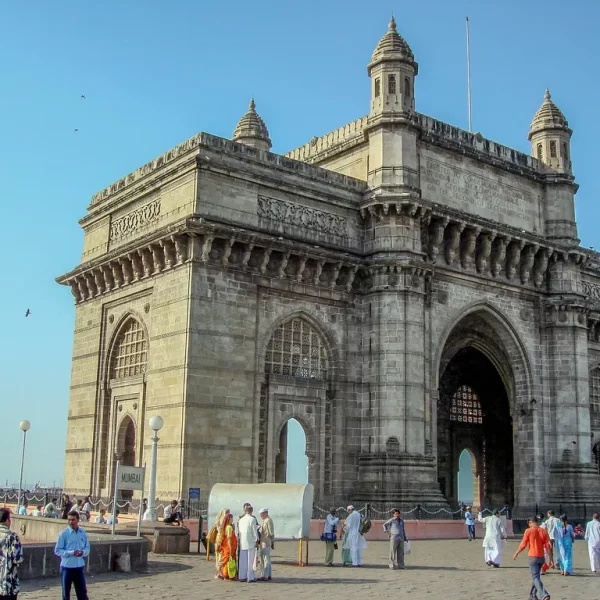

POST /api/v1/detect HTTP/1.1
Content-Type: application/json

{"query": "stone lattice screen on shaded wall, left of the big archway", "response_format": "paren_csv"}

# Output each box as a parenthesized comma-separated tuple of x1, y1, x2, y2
(265, 318, 328, 379)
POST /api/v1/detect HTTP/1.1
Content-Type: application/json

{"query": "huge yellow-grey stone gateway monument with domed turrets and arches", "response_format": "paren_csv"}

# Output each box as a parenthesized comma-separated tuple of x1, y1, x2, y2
(57, 19, 600, 510)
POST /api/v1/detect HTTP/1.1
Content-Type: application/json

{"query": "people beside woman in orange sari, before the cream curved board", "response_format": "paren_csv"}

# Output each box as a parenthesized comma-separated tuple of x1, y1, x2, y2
(207, 502, 275, 583)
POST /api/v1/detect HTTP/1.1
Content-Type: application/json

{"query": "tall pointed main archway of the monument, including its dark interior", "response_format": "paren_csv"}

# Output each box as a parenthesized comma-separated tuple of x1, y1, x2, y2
(433, 303, 540, 508)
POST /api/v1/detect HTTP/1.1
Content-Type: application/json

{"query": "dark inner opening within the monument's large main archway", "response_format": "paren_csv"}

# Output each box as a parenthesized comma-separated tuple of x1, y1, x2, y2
(437, 345, 514, 508)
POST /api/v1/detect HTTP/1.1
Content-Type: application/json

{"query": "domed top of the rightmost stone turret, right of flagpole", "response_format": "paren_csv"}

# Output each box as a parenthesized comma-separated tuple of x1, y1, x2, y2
(529, 90, 573, 175)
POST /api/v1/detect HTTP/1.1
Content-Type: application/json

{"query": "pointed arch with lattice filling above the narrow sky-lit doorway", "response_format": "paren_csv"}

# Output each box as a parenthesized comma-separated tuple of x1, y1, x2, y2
(262, 312, 334, 381)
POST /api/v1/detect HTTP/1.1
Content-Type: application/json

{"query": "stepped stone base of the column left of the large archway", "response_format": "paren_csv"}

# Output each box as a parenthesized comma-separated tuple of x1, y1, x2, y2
(356, 452, 449, 510)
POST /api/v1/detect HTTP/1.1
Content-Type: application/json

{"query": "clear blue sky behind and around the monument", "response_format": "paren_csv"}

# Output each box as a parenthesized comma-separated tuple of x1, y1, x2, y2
(0, 0, 600, 485)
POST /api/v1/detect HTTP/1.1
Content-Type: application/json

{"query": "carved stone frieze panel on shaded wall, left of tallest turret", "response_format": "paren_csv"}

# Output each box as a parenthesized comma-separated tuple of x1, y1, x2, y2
(257, 196, 348, 237)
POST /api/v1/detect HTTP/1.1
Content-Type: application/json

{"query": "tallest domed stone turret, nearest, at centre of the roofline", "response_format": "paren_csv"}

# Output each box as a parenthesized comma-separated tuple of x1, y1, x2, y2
(367, 17, 420, 195)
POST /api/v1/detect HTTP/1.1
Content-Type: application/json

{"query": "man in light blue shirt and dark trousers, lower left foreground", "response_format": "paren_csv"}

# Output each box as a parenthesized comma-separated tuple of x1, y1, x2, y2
(54, 510, 90, 600)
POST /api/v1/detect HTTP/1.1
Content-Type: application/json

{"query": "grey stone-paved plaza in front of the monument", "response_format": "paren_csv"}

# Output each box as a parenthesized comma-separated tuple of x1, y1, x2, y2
(19, 540, 600, 600)
